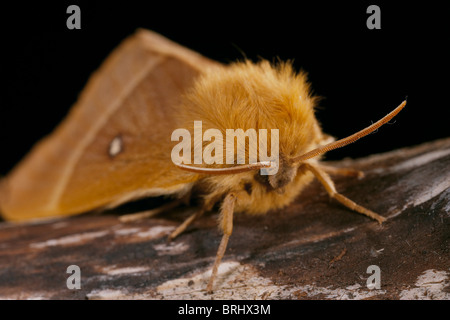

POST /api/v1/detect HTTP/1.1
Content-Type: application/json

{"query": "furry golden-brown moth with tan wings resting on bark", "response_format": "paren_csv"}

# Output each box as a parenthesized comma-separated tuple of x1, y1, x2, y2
(0, 30, 406, 291)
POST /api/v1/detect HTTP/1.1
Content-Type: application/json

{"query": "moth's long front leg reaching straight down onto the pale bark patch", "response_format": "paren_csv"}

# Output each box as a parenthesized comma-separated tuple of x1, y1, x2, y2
(206, 193, 236, 293)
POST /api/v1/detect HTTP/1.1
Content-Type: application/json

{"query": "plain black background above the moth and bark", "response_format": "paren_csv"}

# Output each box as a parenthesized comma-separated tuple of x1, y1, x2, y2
(0, 1, 450, 174)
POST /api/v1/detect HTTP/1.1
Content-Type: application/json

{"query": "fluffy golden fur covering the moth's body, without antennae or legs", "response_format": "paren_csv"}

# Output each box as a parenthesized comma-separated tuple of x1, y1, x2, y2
(179, 61, 327, 214)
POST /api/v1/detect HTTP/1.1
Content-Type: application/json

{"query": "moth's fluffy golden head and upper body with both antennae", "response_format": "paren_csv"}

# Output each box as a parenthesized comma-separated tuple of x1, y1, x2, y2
(172, 57, 406, 192)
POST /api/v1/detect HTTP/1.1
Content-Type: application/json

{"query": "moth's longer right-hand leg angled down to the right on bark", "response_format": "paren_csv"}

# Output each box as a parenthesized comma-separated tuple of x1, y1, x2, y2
(303, 163, 386, 224)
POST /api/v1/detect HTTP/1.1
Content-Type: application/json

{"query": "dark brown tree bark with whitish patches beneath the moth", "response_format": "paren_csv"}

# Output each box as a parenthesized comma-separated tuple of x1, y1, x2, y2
(0, 138, 450, 299)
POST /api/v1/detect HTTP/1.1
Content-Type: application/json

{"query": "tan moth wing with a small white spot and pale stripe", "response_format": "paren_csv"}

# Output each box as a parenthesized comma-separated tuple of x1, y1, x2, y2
(0, 30, 216, 221)
